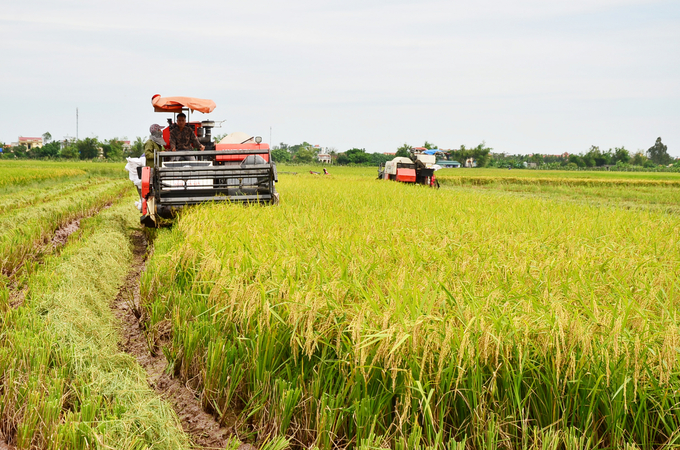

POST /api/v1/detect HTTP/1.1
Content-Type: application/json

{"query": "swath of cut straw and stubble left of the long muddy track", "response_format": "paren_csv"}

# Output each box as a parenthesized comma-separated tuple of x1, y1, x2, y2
(0, 194, 189, 449)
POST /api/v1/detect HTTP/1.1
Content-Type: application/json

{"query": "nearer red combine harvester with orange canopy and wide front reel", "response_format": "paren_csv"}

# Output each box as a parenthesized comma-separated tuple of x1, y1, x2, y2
(140, 95, 279, 228)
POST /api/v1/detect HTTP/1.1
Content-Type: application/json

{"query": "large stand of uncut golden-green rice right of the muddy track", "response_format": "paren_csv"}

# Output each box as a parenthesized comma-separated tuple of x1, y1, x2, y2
(142, 176, 680, 449)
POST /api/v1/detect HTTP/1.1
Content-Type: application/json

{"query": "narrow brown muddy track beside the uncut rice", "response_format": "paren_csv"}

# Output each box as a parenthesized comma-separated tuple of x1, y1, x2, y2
(112, 231, 234, 449)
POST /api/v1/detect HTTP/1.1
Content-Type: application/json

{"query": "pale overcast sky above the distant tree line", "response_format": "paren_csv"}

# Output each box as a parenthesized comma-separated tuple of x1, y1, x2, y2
(0, 0, 680, 156)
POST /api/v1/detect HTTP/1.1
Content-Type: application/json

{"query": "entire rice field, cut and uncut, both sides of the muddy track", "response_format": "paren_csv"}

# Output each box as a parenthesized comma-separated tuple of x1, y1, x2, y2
(0, 161, 680, 450)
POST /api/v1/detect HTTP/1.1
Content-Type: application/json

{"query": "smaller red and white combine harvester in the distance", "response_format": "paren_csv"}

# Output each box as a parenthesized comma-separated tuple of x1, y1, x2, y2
(378, 147, 439, 188)
